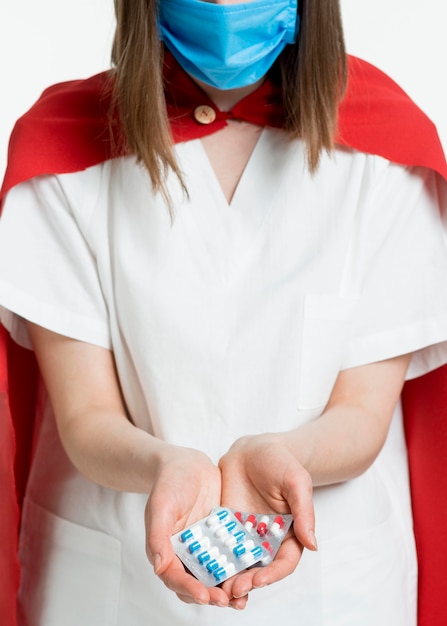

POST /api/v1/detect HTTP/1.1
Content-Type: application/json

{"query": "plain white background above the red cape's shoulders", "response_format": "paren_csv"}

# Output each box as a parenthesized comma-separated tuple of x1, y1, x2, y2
(0, 0, 447, 174)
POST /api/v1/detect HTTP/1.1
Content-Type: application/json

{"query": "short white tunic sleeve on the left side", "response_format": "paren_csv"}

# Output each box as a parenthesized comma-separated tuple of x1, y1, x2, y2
(0, 176, 111, 348)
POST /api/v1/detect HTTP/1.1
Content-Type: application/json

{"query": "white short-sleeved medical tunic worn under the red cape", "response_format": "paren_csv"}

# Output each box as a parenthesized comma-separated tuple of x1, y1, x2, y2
(0, 129, 447, 626)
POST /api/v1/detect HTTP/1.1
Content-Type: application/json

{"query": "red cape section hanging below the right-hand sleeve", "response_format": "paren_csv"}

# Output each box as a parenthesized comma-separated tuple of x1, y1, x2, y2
(402, 366, 447, 626)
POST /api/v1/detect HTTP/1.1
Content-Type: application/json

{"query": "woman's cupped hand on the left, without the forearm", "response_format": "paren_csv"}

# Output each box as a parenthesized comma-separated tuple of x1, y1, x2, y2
(145, 444, 230, 606)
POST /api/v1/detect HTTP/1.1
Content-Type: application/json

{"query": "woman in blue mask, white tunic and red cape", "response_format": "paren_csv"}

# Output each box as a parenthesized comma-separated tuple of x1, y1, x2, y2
(0, 0, 447, 626)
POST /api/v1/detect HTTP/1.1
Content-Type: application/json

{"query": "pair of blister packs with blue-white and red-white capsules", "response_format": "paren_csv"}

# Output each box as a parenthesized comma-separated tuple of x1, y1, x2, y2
(171, 507, 293, 587)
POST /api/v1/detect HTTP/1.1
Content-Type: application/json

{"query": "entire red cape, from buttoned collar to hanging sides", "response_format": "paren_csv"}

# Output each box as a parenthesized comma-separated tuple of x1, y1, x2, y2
(0, 57, 447, 626)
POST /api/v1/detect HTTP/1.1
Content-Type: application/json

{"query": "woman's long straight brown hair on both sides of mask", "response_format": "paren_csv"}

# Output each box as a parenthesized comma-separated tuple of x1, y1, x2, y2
(112, 0, 346, 195)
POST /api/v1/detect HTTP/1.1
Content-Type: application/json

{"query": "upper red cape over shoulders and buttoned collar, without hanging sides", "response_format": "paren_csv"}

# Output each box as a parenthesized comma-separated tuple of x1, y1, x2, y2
(0, 56, 447, 198)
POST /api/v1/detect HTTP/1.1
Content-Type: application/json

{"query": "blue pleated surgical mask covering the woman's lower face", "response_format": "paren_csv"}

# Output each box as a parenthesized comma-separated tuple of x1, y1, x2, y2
(158, 0, 299, 89)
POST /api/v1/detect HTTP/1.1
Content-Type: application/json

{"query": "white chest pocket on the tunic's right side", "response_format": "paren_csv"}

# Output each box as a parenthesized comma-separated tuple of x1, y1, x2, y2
(298, 294, 359, 410)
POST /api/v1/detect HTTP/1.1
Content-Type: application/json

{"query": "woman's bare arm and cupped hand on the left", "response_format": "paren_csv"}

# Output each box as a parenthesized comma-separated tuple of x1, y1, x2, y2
(28, 323, 236, 606)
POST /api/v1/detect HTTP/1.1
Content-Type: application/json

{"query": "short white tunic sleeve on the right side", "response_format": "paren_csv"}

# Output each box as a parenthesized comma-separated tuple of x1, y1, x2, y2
(343, 163, 447, 378)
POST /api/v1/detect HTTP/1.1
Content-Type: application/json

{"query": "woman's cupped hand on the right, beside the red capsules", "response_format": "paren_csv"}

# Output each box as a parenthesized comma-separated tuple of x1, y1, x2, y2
(219, 433, 317, 608)
